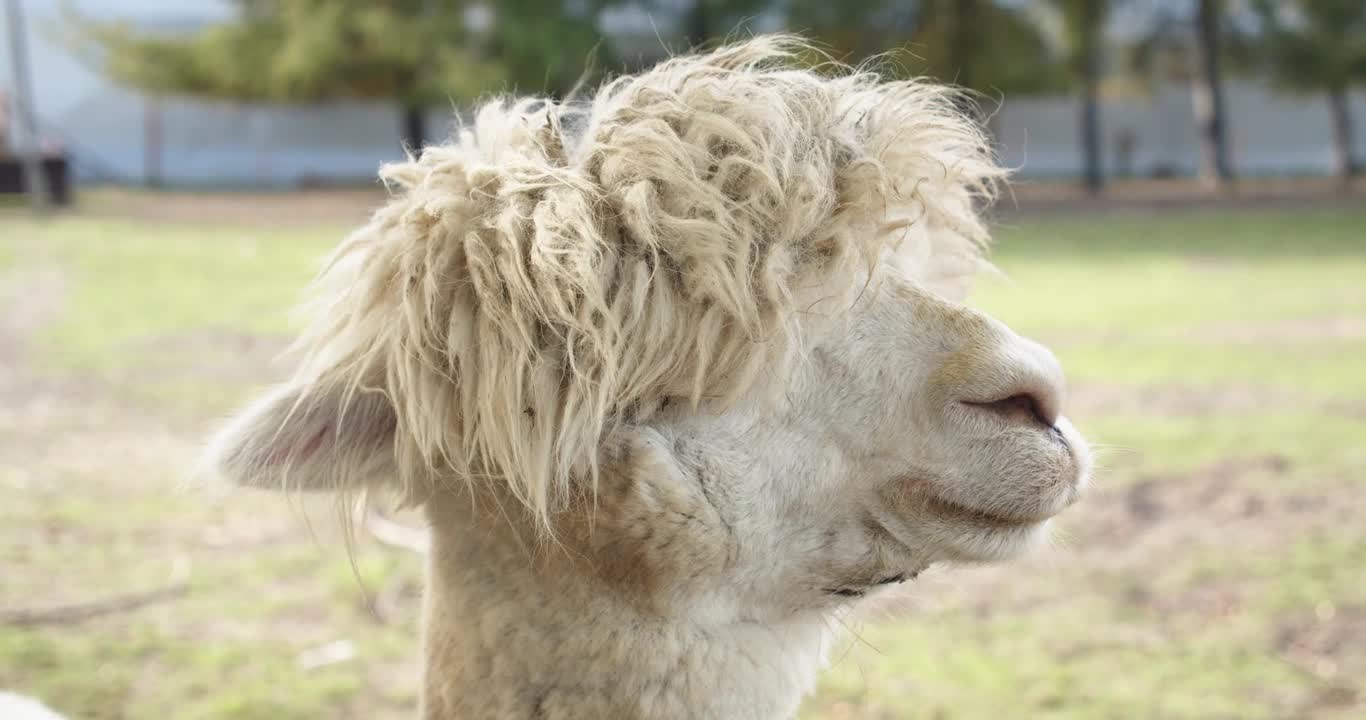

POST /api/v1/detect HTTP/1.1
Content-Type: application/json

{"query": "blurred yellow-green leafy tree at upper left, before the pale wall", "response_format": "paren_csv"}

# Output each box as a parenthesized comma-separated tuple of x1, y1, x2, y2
(70, 0, 504, 148)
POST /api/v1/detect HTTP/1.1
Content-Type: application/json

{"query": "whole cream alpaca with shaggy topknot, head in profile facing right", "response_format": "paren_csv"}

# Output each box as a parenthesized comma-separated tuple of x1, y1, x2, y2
(206, 37, 1090, 719)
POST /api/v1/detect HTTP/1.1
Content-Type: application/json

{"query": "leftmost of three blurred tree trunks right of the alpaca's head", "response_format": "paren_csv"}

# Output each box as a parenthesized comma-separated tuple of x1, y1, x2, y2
(1052, 0, 1111, 194)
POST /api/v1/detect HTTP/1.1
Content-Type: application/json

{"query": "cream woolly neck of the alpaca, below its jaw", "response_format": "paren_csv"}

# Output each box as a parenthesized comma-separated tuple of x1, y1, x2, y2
(422, 493, 829, 720)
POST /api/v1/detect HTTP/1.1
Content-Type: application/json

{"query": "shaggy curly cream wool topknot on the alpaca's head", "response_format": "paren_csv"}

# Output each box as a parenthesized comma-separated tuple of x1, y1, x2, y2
(285, 37, 1001, 527)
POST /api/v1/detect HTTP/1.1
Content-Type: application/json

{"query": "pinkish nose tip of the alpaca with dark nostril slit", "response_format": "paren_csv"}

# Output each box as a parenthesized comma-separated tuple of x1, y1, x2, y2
(960, 337, 1064, 429)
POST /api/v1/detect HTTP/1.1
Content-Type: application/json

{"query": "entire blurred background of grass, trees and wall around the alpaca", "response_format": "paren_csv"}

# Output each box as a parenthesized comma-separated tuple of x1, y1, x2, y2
(0, 0, 1366, 719)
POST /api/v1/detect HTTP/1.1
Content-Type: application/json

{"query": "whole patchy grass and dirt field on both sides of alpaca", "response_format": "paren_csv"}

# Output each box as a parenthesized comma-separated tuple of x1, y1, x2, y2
(0, 198, 1366, 719)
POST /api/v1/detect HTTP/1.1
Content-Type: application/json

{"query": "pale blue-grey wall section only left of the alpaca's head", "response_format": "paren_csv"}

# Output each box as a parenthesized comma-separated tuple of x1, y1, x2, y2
(0, 0, 437, 184)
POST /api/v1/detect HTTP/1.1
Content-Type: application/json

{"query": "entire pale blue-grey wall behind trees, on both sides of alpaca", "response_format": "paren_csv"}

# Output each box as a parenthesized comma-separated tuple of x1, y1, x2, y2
(10, 0, 1366, 184)
